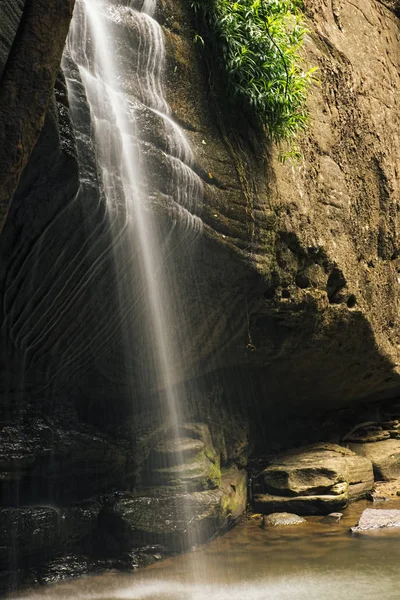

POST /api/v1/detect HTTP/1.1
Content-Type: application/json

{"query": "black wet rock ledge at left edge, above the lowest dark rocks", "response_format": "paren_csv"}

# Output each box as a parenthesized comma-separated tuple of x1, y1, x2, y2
(0, 406, 129, 505)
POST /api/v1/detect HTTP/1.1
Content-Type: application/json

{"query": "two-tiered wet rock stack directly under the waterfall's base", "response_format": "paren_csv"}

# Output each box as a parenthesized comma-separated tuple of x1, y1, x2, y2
(99, 423, 247, 552)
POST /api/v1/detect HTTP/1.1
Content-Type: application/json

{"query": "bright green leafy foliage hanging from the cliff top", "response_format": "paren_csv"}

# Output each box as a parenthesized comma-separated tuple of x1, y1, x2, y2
(192, 0, 315, 144)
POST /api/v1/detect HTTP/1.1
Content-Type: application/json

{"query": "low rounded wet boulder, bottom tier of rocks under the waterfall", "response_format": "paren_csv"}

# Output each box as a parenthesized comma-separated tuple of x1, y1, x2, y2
(99, 467, 247, 552)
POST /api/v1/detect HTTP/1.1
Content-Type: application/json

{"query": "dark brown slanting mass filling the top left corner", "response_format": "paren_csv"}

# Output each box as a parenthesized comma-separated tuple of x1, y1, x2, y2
(0, 0, 75, 230)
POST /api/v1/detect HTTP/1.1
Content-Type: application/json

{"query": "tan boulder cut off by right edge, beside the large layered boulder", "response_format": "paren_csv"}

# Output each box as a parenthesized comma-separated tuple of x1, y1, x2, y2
(350, 439, 400, 481)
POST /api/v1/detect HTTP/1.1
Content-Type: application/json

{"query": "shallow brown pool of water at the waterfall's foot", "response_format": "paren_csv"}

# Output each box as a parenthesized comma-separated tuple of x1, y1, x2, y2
(8, 500, 400, 600)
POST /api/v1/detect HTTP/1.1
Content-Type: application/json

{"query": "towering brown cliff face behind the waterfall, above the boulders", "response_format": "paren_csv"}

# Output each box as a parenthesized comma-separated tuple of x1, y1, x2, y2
(0, 0, 399, 460)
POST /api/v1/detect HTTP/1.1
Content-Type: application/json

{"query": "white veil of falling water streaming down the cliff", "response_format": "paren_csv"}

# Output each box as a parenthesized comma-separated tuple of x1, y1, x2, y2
(67, 0, 202, 431)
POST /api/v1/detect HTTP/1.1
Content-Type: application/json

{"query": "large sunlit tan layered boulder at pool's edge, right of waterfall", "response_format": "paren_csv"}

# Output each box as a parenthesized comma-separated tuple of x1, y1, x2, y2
(254, 444, 374, 515)
